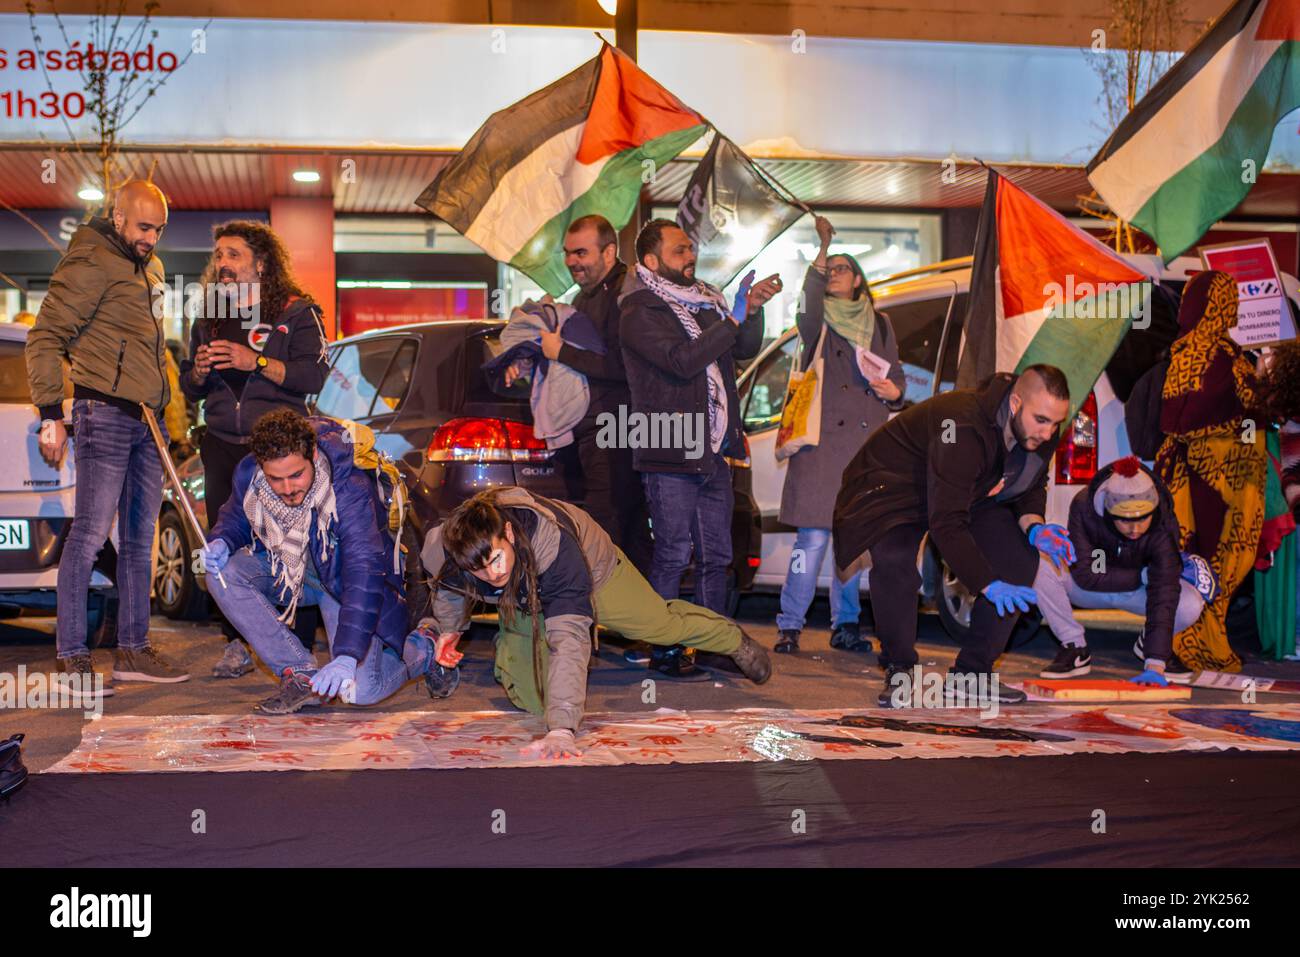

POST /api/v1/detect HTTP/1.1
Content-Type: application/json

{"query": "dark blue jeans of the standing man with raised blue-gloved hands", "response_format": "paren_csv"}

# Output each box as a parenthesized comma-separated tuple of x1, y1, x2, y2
(641, 455, 735, 615)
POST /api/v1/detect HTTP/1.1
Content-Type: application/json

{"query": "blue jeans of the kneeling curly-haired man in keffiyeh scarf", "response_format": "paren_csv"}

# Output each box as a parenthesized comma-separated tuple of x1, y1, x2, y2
(208, 547, 410, 705)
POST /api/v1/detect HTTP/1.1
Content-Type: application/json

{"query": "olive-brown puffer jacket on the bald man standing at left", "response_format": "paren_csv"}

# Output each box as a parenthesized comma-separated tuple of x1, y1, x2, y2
(26, 217, 172, 419)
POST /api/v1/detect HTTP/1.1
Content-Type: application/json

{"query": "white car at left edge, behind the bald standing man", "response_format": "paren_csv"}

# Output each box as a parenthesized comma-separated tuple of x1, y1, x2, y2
(0, 322, 117, 648)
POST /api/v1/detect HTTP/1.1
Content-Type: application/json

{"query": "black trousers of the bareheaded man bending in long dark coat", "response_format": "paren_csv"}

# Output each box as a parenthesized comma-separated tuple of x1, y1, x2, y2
(870, 505, 1039, 672)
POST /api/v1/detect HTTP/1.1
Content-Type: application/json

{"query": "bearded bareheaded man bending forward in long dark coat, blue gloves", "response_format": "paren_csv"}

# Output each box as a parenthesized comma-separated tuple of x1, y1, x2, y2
(832, 365, 1074, 707)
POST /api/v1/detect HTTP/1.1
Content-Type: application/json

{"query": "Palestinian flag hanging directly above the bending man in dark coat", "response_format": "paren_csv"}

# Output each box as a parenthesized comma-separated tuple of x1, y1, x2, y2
(957, 170, 1151, 416)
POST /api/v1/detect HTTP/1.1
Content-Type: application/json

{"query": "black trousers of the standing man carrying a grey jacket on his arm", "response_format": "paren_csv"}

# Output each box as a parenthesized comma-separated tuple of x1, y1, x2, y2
(556, 416, 654, 576)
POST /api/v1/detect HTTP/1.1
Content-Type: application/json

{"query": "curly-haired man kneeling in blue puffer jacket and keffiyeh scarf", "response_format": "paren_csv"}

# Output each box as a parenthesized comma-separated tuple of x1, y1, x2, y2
(203, 408, 433, 714)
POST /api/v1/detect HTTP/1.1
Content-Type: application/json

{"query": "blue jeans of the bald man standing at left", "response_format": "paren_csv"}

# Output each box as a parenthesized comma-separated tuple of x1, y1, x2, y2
(56, 399, 166, 658)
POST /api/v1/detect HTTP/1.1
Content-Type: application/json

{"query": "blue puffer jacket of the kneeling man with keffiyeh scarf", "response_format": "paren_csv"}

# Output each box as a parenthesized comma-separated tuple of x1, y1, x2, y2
(208, 416, 407, 662)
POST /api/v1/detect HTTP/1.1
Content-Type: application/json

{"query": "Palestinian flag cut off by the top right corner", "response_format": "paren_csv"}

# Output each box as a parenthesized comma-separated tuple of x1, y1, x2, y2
(1088, 0, 1300, 263)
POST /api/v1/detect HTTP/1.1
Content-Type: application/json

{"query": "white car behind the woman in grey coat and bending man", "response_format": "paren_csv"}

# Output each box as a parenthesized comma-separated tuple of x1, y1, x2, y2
(738, 256, 1300, 637)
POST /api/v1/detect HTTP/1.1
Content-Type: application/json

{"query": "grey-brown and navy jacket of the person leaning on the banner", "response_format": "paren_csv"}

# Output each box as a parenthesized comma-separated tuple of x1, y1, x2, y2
(420, 486, 619, 731)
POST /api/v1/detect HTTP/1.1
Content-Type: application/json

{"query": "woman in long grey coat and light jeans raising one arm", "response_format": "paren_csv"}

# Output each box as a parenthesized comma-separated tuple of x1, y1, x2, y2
(776, 216, 905, 653)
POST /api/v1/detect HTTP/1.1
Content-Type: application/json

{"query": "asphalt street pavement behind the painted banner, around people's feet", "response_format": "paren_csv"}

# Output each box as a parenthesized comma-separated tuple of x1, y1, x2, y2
(0, 594, 1300, 771)
